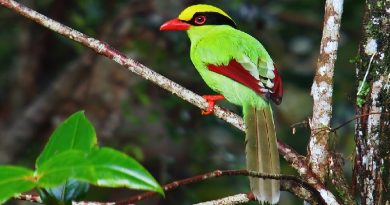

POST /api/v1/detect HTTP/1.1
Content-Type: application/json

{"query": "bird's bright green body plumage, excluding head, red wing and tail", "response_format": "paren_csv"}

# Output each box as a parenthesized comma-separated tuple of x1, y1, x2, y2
(188, 26, 273, 108)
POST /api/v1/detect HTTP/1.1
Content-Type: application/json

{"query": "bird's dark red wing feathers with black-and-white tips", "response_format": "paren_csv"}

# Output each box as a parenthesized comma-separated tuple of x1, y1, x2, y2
(207, 54, 283, 105)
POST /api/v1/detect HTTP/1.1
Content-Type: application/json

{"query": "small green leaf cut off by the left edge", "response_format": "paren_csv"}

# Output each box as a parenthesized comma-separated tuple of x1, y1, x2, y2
(0, 166, 35, 204)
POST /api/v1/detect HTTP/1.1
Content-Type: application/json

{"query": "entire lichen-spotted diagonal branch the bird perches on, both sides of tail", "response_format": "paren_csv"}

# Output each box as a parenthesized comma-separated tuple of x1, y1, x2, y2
(0, 0, 338, 204)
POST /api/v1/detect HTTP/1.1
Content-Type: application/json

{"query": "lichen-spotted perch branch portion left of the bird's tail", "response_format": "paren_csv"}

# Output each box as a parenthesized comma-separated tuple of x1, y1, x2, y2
(0, 0, 245, 130)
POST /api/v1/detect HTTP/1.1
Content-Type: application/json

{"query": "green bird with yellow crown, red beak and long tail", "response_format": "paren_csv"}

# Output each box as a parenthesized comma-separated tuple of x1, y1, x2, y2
(160, 4, 283, 204)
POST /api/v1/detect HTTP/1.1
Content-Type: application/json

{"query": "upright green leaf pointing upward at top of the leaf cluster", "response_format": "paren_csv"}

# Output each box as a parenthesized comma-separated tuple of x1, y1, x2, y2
(36, 111, 97, 167)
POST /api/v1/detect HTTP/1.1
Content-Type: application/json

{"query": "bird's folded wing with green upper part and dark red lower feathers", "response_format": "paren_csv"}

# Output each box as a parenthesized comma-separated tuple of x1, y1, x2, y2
(193, 28, 283, 104)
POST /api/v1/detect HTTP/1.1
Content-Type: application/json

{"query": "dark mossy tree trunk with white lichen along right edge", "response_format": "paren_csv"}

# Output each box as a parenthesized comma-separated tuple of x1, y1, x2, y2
(354, 0, 390, 204)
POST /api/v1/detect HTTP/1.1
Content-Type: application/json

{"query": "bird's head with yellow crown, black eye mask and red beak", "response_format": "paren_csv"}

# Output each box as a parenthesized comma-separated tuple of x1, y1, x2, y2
(160, 4, 236, 31)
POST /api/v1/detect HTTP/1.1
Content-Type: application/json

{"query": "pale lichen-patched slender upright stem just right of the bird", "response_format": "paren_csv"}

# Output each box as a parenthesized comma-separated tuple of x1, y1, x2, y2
(308, 0, 343, 181)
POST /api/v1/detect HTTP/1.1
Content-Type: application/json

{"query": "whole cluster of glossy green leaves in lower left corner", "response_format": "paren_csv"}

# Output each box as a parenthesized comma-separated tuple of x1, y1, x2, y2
(0, 112, 163, 204)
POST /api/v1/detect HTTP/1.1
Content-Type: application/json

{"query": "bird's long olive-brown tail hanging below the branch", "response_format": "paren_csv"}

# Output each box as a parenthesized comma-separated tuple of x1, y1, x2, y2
(243, 105, 280, 204)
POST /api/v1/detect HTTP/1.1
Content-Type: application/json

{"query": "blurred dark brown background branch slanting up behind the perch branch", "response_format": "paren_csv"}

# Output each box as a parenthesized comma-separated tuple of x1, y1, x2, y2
(0, 0, 150, 163)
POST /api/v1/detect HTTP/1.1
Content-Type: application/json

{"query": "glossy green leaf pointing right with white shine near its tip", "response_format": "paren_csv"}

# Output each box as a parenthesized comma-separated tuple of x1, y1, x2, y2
(36, 148, 163, 194)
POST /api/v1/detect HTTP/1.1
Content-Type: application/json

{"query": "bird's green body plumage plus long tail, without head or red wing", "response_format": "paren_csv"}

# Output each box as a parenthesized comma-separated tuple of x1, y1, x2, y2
(187, 25, 280, 203)
